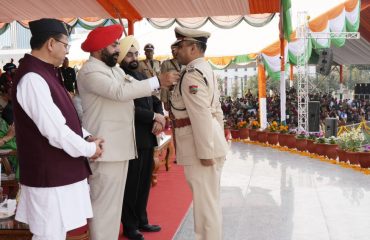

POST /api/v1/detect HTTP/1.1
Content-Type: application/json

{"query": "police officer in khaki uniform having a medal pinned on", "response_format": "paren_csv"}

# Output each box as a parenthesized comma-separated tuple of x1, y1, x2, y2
(170, 28, 228, 240)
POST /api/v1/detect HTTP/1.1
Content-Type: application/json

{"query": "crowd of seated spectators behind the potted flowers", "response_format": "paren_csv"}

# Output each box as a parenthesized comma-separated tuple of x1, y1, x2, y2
(222, 88, 370, 128)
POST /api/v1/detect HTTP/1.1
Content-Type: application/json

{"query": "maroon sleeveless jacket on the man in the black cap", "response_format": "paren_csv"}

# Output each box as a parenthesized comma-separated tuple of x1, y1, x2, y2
(12, 54, 91, 187)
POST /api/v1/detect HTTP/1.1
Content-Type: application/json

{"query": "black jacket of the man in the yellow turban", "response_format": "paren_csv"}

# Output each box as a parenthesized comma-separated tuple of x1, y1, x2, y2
(123, 69, 163, 149)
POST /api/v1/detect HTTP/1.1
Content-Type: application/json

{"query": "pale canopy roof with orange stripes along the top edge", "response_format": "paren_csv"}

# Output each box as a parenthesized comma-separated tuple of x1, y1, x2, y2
(0, 0, 280, 23)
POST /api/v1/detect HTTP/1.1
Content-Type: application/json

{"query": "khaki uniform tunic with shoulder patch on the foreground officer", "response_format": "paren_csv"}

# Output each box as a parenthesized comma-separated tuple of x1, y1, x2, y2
(171, 58, 228, 165)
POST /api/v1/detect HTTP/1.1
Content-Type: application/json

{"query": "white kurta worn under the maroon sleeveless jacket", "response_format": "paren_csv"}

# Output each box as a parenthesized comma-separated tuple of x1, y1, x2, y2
(15, 72, 96, 236)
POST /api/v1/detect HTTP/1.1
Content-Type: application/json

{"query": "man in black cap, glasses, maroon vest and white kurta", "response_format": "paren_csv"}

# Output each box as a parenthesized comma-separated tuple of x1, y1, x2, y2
(12, 19, 102, 240)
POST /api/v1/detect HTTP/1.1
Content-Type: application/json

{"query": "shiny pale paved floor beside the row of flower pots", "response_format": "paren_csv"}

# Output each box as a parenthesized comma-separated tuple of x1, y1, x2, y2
(174, 143, 370, 240)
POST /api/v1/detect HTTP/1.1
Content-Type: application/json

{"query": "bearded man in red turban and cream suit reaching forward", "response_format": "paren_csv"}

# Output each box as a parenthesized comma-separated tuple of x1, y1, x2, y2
(77, 25, 179, 240)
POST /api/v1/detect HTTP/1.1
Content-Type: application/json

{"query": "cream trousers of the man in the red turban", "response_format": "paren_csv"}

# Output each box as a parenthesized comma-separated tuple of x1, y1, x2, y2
(89, 161, 129, 240)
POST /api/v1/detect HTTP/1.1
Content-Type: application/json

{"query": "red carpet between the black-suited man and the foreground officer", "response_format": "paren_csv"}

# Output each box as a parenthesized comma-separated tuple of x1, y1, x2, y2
(119, 161, 192, 240)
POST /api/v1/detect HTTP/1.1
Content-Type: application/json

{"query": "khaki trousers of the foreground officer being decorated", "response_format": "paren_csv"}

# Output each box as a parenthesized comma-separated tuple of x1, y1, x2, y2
(184, 157, 225, 240)
